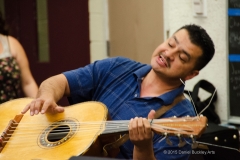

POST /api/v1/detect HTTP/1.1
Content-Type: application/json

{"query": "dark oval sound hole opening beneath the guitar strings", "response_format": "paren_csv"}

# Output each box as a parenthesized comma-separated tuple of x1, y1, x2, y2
(47, 125, 70, 142)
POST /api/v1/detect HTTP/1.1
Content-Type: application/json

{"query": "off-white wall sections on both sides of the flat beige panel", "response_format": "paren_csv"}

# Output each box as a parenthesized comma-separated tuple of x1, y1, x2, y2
(89, 0, 228, 120)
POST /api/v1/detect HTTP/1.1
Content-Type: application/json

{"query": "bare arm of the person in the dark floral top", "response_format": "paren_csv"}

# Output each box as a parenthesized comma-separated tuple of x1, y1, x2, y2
(8, 36, 38, 97)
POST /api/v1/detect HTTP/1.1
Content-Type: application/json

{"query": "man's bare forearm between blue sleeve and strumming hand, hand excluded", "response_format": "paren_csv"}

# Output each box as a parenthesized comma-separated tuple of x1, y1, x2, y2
(36, 74, 69, 102)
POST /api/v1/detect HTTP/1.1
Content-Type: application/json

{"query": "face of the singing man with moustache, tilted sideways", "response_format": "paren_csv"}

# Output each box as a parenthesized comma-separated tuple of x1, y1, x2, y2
(151, 29, 202, 80)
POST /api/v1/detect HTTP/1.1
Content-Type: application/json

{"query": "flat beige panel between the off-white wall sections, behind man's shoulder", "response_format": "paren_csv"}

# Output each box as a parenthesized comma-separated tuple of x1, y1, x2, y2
(108, 0, 163, 63)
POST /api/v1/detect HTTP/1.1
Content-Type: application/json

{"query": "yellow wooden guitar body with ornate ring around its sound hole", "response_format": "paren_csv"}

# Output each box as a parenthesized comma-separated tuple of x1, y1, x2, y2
(0, 98, 107, 160)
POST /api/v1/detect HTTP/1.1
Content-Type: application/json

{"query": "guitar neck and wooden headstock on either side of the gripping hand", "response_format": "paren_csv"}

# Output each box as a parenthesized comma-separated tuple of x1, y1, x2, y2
(99, 116, 207, 137)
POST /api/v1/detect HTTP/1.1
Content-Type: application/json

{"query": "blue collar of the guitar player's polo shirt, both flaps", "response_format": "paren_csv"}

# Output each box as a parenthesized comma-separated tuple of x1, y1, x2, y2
(133, 65, 184, 105)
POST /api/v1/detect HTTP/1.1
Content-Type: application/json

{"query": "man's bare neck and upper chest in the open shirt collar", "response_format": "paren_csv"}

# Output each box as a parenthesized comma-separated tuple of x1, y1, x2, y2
(141, 70, 182, 97)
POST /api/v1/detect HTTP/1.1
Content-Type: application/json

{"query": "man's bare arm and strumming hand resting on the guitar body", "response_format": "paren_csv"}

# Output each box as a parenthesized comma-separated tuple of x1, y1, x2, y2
(22, 74, 70, 115)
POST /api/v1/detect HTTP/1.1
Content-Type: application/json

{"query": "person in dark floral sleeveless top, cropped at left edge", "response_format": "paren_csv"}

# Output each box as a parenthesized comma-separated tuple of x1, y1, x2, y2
(0, 12, 38, 103)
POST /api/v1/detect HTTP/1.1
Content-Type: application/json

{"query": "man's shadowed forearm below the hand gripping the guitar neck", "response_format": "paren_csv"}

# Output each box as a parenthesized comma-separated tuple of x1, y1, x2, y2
(133, 146, 156, 160)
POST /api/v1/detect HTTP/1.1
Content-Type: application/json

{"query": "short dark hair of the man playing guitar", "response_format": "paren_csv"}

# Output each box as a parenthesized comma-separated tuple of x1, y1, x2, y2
(177, 24, 215, 70)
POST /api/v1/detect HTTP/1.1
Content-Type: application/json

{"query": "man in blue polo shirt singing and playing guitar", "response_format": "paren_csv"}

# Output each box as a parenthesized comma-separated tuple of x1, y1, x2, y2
(22, 24, 215, 160)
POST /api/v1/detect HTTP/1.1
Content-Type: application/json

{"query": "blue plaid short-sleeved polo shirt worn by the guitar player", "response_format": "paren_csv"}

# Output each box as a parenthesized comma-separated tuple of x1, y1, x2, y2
(63, 57, 196, 160)
